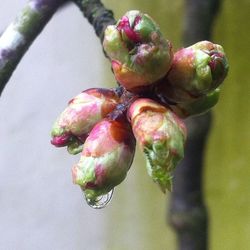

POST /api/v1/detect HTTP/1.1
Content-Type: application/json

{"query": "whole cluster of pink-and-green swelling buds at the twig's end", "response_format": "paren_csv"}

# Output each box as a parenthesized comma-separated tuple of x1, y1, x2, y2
(51, 10, 228, 205)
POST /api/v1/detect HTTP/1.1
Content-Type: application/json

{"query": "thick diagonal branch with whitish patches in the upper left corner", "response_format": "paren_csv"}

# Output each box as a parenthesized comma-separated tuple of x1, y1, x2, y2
(0, 0, 66, 95)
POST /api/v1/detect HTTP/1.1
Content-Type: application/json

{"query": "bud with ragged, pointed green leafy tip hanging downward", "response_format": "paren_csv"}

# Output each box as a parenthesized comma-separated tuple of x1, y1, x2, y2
(128, 98, 186, 192)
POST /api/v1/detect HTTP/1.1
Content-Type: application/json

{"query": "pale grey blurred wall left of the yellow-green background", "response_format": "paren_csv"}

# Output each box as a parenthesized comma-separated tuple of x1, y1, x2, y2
(0, 0, 109, 250)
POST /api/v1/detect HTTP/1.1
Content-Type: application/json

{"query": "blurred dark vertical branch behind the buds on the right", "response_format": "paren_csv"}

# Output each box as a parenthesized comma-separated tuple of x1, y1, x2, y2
(169, 0, 220, 250)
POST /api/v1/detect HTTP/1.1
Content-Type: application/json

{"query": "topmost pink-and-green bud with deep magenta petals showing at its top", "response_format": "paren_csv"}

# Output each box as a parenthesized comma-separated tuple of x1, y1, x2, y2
(103, 10, 173, 92)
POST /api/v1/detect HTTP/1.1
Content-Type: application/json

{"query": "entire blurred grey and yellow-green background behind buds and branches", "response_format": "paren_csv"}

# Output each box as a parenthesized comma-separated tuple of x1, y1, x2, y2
(0, 0, 250, 250)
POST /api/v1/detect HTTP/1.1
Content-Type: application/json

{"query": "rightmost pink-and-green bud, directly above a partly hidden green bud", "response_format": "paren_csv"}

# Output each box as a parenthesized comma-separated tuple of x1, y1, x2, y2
(156, 41, 229, 103)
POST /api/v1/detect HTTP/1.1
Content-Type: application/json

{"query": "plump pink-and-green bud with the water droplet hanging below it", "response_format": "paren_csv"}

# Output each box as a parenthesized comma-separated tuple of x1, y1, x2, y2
(72, 118, 135, 204)
